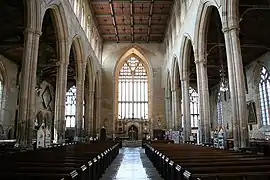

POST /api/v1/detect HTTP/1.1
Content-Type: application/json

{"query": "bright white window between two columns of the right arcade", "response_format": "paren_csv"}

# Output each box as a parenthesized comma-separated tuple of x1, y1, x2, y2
(189, 87, 200, 127)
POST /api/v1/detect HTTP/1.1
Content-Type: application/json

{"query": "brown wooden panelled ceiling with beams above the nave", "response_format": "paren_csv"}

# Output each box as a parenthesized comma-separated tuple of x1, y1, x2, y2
(89, 0, 174, 42)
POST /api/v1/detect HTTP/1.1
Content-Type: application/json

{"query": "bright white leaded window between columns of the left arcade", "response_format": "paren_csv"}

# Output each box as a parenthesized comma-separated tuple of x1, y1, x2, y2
(66, 86, 76, 128)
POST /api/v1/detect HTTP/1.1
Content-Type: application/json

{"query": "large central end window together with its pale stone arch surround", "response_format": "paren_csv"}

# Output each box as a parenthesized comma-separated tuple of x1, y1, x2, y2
(114, 47, 153, 124)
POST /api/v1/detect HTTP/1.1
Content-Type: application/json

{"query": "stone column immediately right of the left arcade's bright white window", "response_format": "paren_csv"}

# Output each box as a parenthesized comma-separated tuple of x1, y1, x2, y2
(75, 64, 86, 141)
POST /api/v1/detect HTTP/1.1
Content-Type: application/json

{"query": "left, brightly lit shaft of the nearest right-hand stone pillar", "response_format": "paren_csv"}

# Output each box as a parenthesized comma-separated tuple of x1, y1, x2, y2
(223, 28, 240, 150)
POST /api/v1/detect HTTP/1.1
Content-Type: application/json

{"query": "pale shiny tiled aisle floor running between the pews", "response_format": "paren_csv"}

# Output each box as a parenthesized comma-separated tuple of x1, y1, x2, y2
(101, 147, 162, 180)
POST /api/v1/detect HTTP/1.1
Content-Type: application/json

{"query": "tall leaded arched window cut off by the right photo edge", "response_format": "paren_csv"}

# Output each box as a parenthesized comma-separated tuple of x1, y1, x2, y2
(259, 66, 270, 126)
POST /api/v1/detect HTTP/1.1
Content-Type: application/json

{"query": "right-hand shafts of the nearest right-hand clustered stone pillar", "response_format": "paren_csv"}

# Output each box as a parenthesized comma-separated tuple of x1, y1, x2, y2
(229, 27, 249, 148)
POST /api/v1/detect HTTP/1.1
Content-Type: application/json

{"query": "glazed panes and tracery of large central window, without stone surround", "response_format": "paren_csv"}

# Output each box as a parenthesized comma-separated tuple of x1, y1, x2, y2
(118, 56, 148, 120)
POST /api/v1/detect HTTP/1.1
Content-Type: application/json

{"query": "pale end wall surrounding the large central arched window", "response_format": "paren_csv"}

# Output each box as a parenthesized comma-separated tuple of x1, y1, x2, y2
(101, 43, 164, 135)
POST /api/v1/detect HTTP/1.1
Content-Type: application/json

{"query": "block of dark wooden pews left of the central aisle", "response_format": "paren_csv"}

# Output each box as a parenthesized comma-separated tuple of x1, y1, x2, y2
(0, 142, 119, 180)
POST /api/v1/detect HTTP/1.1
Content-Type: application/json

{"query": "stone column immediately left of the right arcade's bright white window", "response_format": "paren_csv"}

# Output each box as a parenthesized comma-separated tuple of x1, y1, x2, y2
(181, 78, 191, 141)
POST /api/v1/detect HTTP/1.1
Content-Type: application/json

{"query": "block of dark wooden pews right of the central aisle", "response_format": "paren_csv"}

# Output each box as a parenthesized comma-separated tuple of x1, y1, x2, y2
(146, 144, 270, 180)
